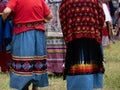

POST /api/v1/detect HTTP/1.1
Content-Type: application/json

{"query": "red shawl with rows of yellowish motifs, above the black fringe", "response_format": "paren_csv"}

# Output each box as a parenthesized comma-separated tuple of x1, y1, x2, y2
(59, 0, 105, 44)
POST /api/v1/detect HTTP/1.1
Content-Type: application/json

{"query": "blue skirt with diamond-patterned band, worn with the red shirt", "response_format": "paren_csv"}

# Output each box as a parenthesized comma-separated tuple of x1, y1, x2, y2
(10, 30, 48, 90)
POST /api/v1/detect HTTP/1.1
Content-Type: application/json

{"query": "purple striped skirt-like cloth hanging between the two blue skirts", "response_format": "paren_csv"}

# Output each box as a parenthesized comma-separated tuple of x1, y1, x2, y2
(47, 34, 66, 73)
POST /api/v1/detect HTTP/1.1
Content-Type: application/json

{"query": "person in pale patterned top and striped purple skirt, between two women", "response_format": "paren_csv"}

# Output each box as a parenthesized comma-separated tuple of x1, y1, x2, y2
(46, 0, 66, 75)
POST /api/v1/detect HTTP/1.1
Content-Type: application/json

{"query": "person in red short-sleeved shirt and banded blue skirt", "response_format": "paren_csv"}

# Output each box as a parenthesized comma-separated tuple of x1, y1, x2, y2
(2, 0, 52, 90)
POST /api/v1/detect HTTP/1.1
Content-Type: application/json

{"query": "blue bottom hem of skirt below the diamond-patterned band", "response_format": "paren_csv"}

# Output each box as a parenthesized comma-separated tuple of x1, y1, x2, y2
(10, 72, 48, 90)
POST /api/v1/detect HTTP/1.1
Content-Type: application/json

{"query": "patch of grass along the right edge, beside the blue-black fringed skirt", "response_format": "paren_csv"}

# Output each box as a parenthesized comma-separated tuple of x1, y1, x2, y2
(104, 41, 120, 90)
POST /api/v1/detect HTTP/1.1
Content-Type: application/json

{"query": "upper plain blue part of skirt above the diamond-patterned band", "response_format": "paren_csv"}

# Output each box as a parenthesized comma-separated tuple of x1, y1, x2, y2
(12, 30, 46, 56)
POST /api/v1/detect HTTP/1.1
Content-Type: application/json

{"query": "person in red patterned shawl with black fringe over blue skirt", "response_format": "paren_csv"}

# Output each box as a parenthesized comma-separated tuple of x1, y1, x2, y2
(59, 0, 105, 90)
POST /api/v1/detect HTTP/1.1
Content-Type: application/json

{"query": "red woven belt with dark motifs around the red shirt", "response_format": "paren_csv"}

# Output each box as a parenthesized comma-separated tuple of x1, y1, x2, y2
(14, 21, 45, 28)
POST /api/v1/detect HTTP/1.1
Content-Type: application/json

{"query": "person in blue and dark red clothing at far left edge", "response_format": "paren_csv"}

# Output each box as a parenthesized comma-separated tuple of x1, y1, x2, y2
(0, 0, 11, 72)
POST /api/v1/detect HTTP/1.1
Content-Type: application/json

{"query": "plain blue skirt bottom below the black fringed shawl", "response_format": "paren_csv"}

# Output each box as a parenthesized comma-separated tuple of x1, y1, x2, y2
(66, 73, 103, 90)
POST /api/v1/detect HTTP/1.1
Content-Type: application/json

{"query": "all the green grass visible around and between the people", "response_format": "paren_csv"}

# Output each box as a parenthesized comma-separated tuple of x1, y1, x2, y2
(0, 41, 120, 90)
